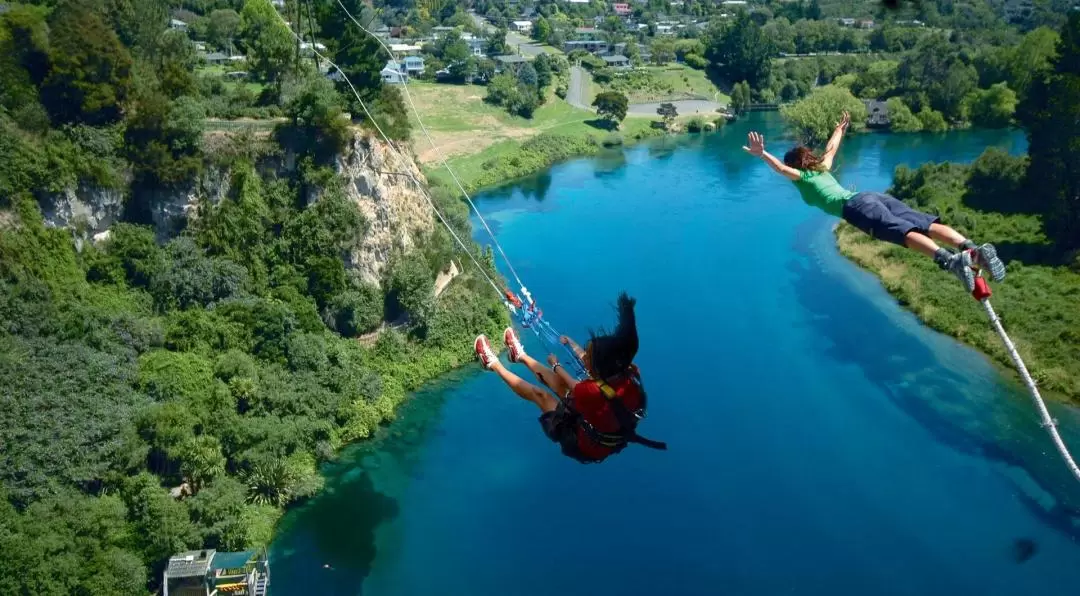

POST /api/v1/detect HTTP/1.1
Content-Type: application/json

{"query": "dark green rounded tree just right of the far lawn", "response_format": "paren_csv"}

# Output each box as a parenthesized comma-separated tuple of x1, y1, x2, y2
(705, 12, 775, 87)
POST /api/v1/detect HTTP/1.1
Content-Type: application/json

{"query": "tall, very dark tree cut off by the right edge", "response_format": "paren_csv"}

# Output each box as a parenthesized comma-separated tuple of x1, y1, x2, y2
(1018, 12, 1080, 248)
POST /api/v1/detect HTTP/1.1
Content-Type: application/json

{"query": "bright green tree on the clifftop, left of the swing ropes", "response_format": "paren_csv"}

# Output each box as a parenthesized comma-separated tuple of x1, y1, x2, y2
(240, 0, 293, 82)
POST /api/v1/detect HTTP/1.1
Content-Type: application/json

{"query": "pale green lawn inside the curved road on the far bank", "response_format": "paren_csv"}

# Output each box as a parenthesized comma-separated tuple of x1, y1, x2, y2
(589, 64, 730, 104)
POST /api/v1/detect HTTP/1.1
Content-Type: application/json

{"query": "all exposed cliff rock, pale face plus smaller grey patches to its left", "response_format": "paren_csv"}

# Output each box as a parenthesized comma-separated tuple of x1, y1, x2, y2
(41, 131, 435, 284)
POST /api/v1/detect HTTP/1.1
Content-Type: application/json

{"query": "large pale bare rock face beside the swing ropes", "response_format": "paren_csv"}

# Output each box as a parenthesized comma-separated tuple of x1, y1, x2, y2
(337, 132, 435, 284)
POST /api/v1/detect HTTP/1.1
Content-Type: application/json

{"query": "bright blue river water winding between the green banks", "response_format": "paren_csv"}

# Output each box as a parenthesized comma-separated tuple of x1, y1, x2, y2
(271, 114, 1080, 596)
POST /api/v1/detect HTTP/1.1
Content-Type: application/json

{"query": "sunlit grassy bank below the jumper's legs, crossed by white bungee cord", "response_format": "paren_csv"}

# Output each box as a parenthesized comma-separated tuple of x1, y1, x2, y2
(835, 222, 1080, 405)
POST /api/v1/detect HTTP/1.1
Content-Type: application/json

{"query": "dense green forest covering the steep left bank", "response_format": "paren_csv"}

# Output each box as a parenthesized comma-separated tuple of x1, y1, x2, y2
(0, 0, 507, 595)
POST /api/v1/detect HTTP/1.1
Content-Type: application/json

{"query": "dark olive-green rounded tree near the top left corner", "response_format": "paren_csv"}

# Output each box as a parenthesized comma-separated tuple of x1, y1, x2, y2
(41, 0, 132, 124)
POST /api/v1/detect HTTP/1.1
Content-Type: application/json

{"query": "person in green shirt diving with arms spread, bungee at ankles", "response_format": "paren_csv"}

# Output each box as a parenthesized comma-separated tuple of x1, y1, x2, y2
(743, 112, 1005, 292)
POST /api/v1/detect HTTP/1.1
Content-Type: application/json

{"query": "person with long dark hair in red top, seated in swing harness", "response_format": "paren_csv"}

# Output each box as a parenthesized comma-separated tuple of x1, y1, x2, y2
(474, 293, 667, 463)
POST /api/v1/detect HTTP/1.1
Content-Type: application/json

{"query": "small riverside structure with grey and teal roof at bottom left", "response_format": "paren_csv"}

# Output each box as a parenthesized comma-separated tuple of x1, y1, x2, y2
(161, 550, 270, 596)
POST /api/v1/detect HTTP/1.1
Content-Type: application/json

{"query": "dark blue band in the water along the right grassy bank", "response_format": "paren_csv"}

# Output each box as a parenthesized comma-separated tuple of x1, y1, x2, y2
(788, 220, 1080, 540)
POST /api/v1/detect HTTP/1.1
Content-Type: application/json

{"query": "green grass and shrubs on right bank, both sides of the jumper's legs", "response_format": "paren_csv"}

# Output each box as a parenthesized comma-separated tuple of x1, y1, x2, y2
(837, 164, 1080, 404)
